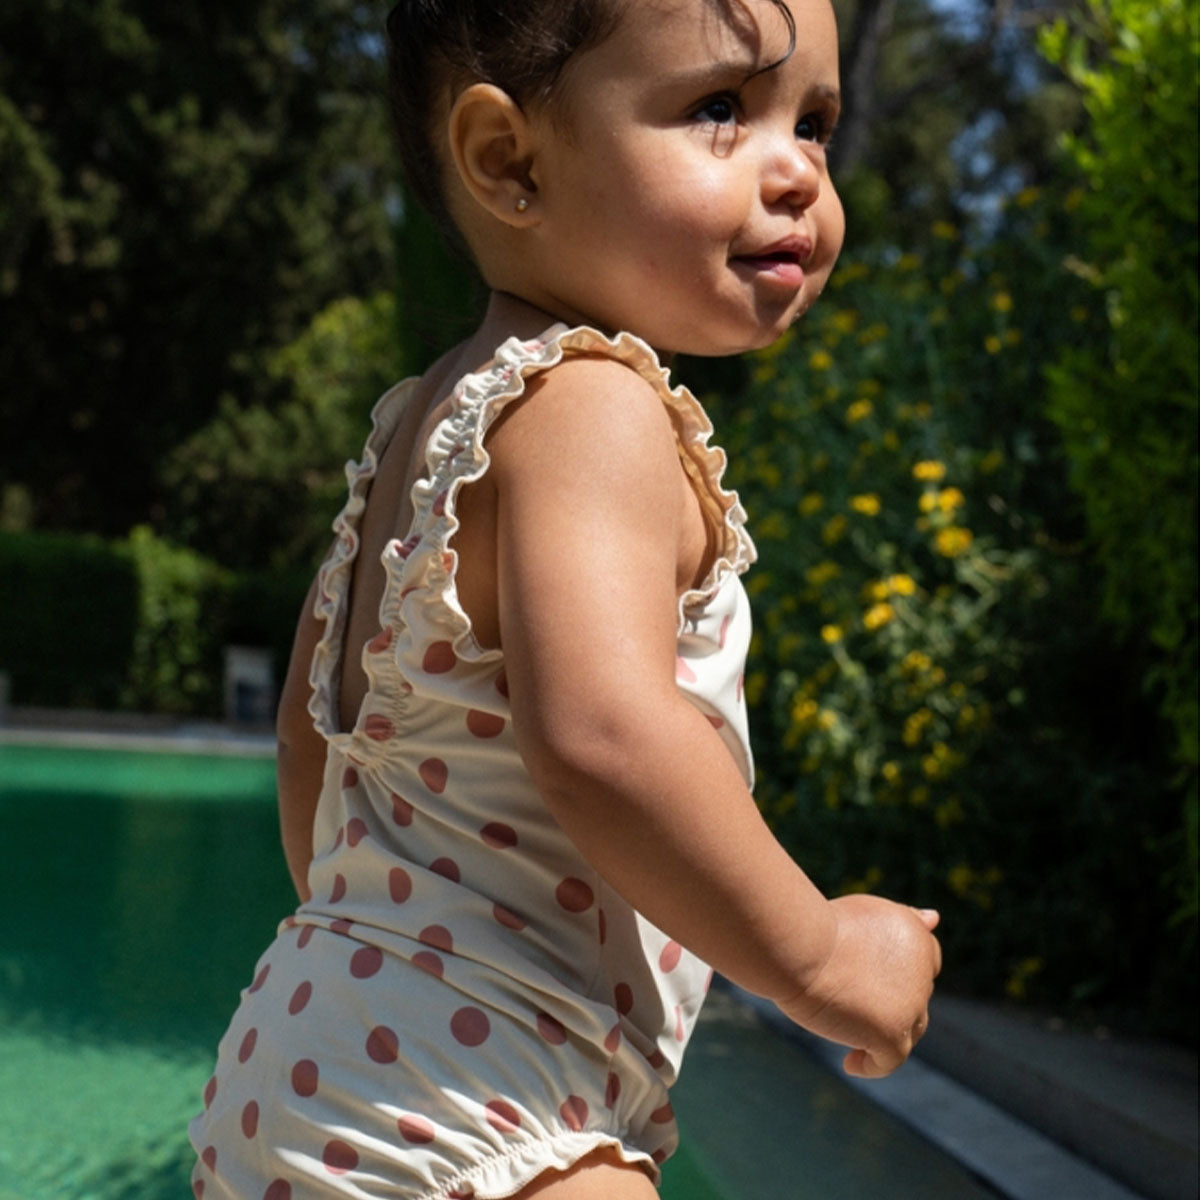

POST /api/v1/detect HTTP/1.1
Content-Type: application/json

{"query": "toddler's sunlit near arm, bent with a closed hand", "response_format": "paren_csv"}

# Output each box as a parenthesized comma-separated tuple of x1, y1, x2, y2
(485, 360, 938, 1075)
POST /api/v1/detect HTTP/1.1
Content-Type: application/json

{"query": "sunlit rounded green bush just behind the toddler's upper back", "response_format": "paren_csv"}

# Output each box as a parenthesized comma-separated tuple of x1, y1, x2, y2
(164, 293, 402, 570)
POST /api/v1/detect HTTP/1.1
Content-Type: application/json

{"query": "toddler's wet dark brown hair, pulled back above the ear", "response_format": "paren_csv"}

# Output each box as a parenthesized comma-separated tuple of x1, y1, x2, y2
(388, 0, 796, 235)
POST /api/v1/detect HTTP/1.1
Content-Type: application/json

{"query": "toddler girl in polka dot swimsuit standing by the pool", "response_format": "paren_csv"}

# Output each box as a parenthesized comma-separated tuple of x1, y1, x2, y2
(191, 0, 938, 1200)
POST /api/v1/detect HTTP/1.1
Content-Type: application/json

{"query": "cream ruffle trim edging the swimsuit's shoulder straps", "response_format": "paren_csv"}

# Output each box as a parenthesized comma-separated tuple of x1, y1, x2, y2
(308, 324, 756, 740)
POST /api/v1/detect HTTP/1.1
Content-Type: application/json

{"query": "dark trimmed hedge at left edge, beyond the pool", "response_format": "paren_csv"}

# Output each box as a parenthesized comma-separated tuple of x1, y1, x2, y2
(0, 532, 138, 707)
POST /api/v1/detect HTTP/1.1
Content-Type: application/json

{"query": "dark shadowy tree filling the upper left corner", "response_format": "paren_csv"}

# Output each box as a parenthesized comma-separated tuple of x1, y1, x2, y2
(0, 0, 394, 534)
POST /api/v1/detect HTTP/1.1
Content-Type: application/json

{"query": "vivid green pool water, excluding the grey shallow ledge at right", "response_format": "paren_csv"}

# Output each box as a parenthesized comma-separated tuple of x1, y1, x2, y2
(0, 745, 731, 1200)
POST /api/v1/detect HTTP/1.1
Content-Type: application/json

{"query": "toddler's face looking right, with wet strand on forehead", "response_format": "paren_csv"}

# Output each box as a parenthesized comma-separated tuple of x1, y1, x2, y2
(525, 0, 845, 354)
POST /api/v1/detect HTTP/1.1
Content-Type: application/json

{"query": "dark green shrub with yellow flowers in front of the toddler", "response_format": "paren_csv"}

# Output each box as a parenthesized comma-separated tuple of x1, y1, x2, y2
(713, 191, 1194, 1032)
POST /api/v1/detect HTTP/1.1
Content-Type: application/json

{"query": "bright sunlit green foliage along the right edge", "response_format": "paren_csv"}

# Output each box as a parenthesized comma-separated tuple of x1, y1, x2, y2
(1042, 0, 1200, 920)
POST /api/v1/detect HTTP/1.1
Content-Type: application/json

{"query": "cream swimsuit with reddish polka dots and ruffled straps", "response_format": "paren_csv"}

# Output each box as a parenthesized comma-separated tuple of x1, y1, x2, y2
(191, 325, 754, 1200)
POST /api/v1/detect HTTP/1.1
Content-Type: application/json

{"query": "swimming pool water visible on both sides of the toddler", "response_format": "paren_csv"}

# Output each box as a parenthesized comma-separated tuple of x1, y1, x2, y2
(0, 742, 994, 1200)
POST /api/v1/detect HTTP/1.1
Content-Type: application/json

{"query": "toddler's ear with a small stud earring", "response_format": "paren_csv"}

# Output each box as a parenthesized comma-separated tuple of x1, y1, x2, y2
(448, 83, 538, 227)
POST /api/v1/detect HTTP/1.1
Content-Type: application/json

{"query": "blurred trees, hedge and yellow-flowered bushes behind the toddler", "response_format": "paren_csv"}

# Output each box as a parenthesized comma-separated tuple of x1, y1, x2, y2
(0, 0, 1198, 1044)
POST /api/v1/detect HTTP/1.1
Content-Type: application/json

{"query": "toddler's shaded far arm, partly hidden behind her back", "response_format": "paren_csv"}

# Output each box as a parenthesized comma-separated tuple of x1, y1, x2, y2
(275, 581, 325, 900)
